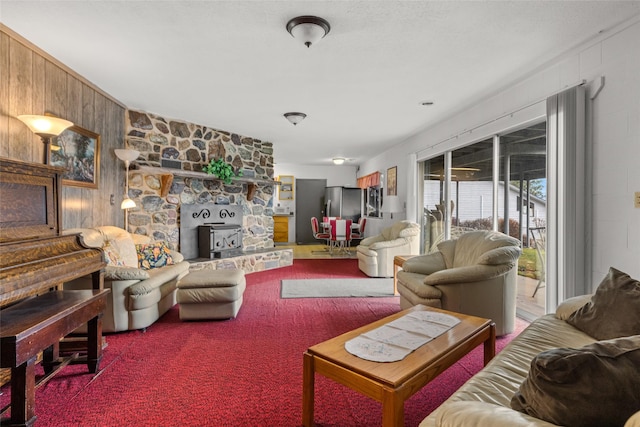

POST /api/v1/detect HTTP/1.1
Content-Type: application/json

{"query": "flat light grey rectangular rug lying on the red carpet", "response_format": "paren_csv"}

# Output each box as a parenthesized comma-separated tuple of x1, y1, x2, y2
(280, 277, 393, 298)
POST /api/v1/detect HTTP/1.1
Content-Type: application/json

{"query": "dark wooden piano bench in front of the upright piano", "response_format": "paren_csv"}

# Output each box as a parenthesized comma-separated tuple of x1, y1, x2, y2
(0, 289, 110, 426)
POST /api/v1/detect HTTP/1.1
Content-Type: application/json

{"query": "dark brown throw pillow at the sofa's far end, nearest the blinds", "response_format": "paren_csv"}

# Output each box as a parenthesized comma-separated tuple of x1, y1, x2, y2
(567, 267, 640, 340)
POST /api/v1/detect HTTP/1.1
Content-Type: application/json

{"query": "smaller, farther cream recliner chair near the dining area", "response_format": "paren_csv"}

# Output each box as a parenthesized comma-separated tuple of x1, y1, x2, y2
(357, 221, 420, 277)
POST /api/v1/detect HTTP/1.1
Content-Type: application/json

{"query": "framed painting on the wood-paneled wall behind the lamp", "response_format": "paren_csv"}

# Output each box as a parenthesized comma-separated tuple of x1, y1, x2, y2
(51, 126, 100, 188)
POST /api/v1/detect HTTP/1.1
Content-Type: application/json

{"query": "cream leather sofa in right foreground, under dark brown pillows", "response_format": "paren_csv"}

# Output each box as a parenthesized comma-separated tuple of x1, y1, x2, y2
(420, 295, 640, 427)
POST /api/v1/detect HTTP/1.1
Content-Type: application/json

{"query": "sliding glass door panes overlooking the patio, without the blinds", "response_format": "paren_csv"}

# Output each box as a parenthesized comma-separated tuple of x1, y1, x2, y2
(420, 122, 547, 318)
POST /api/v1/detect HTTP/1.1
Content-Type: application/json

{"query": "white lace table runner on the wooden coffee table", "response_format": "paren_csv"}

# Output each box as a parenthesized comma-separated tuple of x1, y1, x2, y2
(344, 311, 460, 362)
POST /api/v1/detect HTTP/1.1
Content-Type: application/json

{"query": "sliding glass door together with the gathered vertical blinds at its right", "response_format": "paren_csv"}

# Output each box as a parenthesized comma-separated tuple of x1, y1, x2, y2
(418, 86, 592, 317)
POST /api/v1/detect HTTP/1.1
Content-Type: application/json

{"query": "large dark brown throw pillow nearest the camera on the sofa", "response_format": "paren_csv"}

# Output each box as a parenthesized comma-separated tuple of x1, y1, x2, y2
(511, 335, 640, 427)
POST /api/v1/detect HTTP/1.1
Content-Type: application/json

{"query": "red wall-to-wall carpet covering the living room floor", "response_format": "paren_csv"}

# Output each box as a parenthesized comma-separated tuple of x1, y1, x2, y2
(0, 259, 526, 427)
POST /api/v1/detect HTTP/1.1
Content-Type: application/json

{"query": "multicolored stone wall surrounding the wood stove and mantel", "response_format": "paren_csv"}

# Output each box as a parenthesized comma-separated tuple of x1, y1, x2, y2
(126, 110, 274, 251)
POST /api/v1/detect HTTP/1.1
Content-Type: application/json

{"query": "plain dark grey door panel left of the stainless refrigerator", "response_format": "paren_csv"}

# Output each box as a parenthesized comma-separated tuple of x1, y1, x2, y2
(295, 179, 327, 245)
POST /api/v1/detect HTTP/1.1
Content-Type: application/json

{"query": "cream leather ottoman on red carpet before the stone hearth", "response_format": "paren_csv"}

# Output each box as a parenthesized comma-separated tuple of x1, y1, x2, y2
(176, 269, 247, 320)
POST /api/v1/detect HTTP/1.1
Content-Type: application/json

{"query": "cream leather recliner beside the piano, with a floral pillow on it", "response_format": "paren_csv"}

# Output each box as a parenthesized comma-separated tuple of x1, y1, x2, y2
(64, 226, 189, 332)
